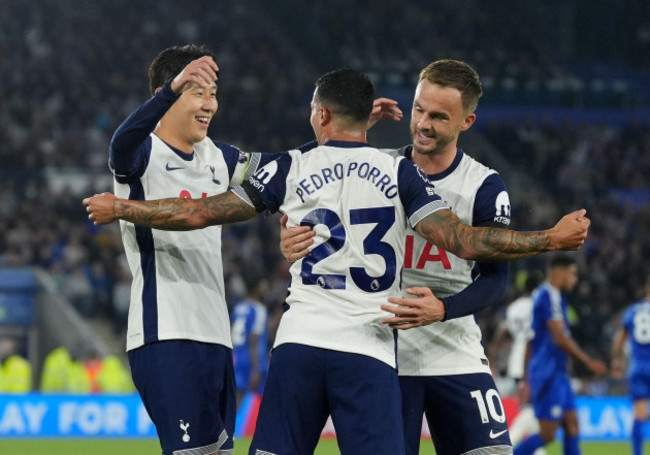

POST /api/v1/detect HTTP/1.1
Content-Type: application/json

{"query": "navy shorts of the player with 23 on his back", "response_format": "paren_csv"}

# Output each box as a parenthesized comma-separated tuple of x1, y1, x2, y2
(249, 343, 404, 455)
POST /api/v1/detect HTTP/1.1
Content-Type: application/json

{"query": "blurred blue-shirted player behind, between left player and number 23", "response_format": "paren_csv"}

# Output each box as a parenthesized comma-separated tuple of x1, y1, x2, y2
(231, 273, 269, 408)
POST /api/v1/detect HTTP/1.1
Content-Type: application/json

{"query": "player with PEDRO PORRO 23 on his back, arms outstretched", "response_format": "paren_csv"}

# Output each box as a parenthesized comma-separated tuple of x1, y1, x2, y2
(84, 70, 589, 454)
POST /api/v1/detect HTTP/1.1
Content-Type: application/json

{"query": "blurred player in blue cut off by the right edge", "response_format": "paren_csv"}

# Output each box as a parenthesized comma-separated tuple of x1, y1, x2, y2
(612, 280, 650, 455)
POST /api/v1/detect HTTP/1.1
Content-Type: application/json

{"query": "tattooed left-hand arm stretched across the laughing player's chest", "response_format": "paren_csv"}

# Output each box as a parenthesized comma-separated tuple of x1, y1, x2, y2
(83, 191, 257, 231)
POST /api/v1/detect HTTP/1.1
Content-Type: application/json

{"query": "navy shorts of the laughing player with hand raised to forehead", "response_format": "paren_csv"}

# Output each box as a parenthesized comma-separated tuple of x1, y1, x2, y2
(129, 340, 237, 455)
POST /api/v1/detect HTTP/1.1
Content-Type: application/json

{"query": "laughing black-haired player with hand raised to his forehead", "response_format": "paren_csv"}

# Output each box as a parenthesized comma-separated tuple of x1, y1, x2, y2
(109, 45, 270, 455)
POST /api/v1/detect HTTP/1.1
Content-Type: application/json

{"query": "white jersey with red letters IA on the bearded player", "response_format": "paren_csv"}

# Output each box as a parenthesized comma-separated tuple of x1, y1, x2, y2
(393, 150, 510, 376)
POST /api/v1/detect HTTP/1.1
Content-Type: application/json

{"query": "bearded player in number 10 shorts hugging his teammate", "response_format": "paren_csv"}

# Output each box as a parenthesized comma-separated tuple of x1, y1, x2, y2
(282, 60, 512, 455)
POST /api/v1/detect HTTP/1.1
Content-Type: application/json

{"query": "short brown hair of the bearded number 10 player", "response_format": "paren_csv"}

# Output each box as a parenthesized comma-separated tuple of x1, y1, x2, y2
(418, 59, 483, 112)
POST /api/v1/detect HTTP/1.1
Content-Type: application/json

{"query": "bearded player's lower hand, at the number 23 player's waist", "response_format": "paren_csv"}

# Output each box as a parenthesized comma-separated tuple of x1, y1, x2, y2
(381, 287, 445, 330)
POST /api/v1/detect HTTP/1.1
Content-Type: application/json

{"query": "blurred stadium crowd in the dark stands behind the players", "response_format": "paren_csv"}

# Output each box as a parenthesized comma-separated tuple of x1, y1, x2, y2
(0, 0, 650, 396)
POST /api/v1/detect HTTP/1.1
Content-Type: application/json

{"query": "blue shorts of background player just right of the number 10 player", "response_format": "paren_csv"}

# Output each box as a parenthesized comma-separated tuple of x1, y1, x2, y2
(530, 374, 576, 422)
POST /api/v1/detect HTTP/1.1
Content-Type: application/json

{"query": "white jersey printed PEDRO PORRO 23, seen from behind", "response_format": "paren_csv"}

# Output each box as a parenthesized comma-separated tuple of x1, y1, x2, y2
(235, 141, 445, 367)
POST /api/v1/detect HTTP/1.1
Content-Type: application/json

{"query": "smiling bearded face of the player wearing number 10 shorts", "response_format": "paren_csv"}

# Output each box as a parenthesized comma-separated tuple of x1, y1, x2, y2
(410, 79, 476, 159)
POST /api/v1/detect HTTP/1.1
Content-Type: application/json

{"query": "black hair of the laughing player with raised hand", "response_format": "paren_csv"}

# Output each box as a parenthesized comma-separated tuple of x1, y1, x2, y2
(149, 44, 217, 95)
